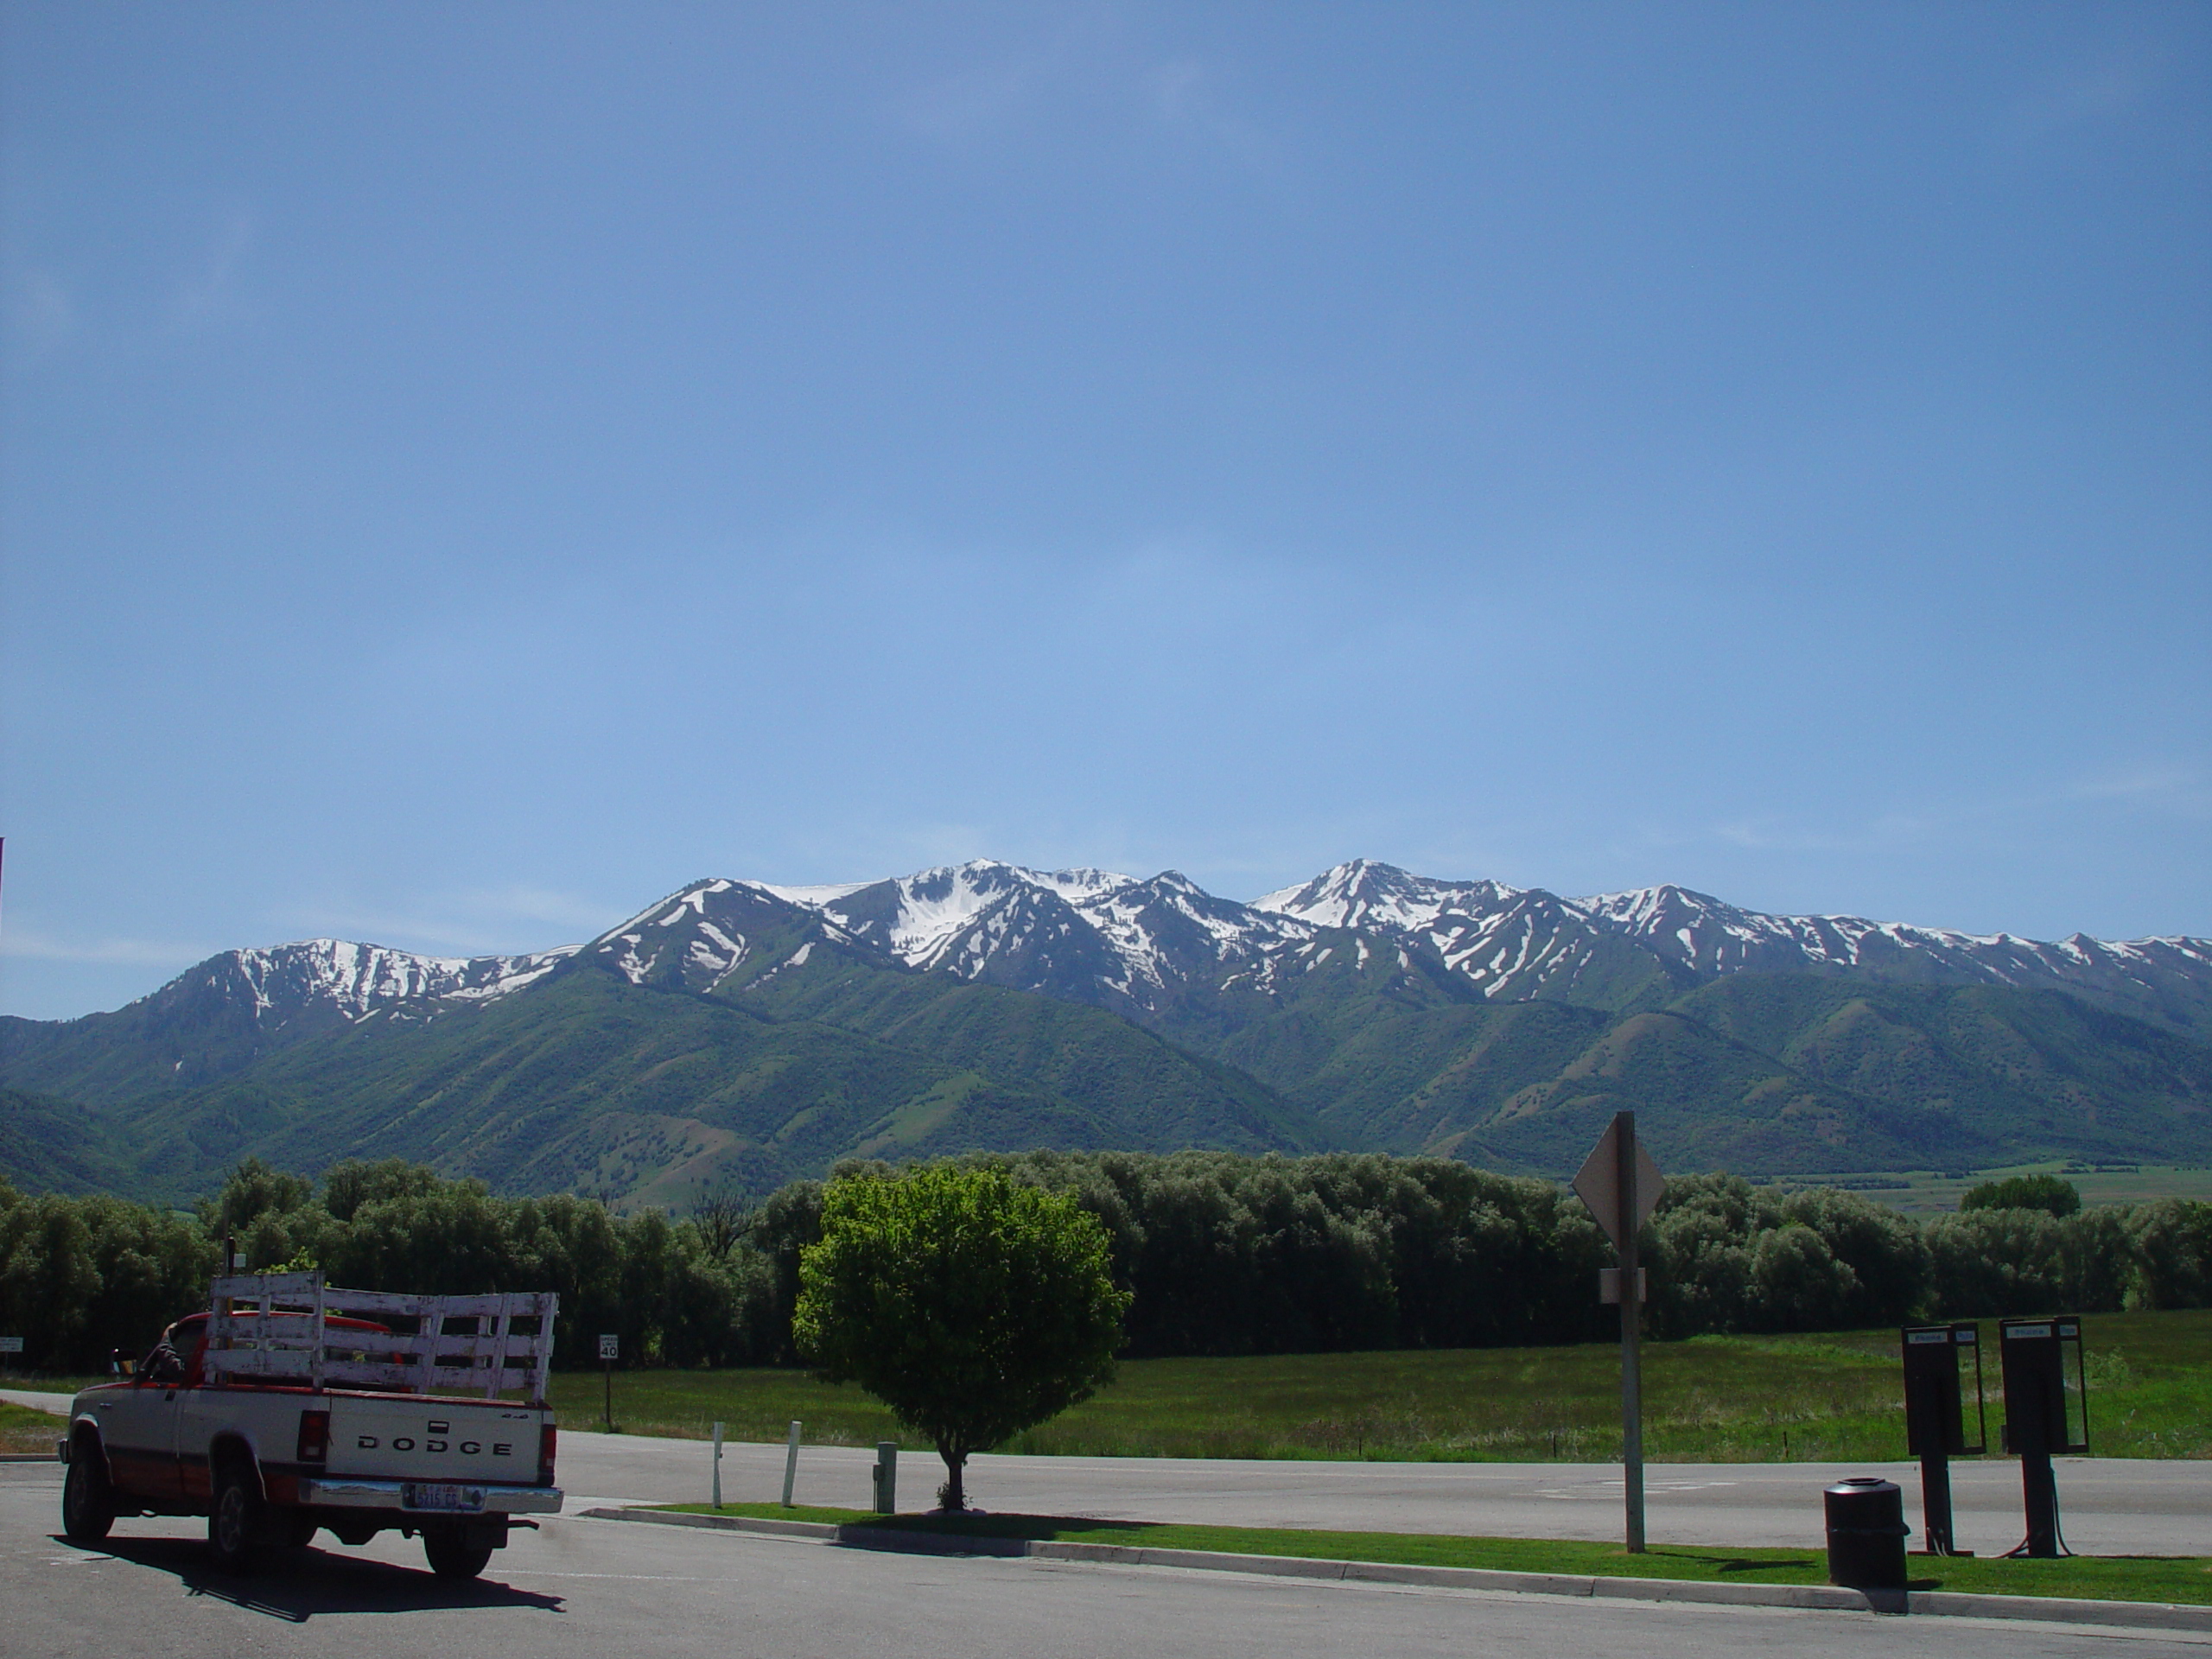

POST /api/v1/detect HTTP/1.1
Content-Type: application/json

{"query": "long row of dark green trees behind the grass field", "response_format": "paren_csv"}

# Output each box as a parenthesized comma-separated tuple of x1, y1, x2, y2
(0, 1153, 2212, 1374)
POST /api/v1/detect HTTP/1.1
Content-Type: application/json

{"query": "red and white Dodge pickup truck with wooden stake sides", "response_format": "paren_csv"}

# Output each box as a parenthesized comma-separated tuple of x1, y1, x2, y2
(60, 1274, 562, 1577)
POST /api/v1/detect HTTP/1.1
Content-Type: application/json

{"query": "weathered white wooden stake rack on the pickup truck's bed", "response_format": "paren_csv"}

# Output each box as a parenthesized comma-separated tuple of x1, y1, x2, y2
(199, 1272, 560, 1405)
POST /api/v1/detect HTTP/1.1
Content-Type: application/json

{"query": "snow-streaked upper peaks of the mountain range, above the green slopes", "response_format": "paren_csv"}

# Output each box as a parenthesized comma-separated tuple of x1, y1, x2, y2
(117, 861, 2212, 1031)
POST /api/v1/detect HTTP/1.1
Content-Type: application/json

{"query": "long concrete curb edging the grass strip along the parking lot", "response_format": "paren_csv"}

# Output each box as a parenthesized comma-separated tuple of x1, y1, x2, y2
(584, 1509, 2212, 1635)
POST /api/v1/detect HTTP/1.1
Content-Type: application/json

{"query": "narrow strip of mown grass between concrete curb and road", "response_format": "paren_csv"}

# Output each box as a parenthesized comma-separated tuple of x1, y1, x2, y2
(652, 1504, 2212, 1606)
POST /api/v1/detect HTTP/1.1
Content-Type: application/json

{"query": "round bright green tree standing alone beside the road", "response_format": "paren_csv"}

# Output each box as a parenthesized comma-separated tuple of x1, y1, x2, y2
(791, 1166, 1130, 1509)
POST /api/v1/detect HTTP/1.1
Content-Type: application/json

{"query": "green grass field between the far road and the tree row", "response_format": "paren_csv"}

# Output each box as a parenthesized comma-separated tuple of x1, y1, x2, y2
(553, 1310, 2212, 1462)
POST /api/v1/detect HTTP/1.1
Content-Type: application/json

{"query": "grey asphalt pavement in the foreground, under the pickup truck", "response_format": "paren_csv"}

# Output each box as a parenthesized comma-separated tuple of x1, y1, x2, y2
(0, 1465, 2212, 1659)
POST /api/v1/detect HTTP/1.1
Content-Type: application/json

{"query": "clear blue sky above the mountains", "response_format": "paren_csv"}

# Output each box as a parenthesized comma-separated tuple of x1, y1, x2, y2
(0, 0, 2212, 1018)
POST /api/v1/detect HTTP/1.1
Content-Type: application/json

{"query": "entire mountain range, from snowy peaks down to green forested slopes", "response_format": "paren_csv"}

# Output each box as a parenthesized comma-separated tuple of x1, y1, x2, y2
(0, 861, 2212, 1205)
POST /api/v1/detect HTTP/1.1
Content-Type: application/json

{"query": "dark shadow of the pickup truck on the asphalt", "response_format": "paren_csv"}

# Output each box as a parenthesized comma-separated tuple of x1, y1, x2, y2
(53, 1533, 566, 1624)
